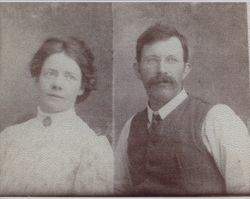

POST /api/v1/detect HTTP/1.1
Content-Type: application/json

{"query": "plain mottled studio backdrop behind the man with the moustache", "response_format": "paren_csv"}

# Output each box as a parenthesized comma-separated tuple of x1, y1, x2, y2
(113, 2, 249, 144)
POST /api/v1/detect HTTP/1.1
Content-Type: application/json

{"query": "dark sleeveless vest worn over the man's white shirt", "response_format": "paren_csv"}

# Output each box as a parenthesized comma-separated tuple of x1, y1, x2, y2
(127, 97, 225, 196)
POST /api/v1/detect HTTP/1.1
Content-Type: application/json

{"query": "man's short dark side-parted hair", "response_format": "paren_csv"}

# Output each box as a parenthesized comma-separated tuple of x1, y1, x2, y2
(136, 23, 188, 63)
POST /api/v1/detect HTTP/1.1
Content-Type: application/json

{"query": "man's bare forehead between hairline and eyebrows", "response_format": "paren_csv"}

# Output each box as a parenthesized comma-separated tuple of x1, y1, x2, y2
(142, 36, 183, 56)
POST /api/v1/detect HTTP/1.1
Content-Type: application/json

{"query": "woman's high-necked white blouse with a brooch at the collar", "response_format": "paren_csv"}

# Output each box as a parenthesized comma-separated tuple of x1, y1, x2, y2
(0, 109, 113, 196)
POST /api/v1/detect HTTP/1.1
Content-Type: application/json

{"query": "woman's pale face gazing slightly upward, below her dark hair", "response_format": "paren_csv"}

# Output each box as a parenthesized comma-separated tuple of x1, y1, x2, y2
(38, 53, 84, 113)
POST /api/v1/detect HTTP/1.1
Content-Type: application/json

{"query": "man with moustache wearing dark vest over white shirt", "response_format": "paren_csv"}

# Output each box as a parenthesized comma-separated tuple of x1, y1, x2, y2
(115, 24, 250, 196)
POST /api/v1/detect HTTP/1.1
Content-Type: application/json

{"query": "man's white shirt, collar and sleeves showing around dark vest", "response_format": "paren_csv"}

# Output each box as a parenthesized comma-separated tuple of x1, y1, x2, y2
(115, 90, 250, 194)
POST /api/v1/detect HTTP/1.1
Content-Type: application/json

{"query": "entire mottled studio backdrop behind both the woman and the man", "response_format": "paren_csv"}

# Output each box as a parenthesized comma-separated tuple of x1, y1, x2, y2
(0, 2, 250, 146)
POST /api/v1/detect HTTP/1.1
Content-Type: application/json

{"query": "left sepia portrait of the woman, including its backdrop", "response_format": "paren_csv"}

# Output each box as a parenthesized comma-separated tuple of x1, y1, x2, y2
(0, 3, 114, 196)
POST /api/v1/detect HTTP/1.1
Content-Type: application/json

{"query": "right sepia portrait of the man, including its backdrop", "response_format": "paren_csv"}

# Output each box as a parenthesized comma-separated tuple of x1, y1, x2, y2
(113, 2, 250, 196)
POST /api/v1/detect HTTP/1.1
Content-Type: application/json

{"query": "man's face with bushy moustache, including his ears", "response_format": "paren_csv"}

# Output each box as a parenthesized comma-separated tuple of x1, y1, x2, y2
(135, 37, 190, 102)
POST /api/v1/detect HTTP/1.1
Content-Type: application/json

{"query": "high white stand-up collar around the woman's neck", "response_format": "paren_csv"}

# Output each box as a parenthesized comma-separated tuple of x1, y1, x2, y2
(37, 107, 76, 122)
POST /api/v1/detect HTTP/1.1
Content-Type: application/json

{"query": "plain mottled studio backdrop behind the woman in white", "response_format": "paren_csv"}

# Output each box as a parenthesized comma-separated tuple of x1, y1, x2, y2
(0, 3, 113, 141)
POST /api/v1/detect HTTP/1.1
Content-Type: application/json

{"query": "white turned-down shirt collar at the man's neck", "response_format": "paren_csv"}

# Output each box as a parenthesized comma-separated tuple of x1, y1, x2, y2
(147, 89, 188, 123)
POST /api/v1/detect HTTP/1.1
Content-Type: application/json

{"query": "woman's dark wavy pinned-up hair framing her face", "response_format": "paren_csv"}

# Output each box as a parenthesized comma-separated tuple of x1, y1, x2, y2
(30, 37, 97, 103)
